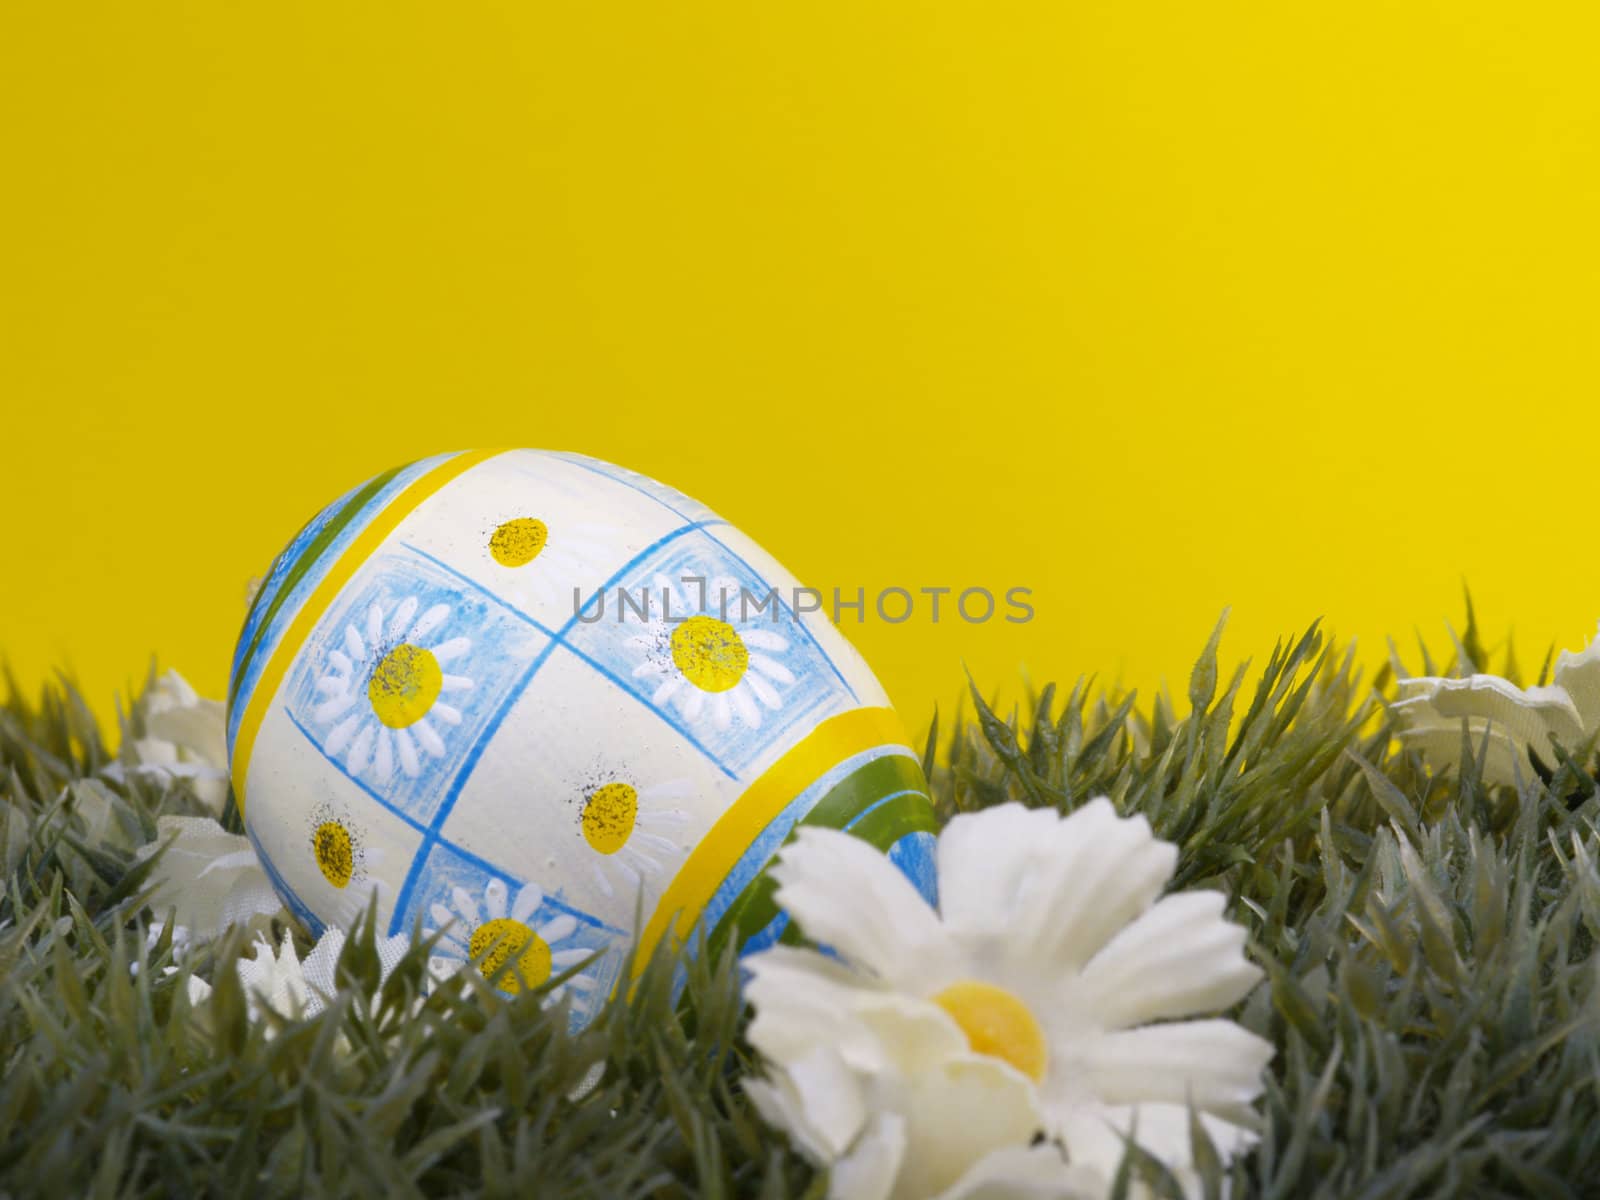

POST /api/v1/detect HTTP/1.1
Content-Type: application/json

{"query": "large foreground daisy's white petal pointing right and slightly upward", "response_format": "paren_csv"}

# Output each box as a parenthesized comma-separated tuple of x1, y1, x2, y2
(1080, 891, 1261, 1029)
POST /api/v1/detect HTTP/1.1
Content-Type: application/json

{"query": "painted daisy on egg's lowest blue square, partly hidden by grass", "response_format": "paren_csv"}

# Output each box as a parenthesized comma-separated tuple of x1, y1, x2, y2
(424, 878, 595, 1006)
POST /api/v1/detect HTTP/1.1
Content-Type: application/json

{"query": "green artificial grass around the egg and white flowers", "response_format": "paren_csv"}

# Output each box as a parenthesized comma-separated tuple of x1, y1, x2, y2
(0, 613, 1600, 1200)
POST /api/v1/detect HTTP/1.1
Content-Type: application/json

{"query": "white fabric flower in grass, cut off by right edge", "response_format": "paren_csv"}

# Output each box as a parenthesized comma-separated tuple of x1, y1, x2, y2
(1389, 637, 1600, 786)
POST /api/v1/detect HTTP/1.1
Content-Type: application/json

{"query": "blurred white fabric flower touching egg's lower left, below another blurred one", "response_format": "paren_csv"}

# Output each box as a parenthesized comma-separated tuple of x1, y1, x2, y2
(138, 816, 283, 941)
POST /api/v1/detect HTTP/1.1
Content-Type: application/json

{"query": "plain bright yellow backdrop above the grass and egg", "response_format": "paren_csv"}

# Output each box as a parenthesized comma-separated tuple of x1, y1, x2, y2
(0, 0, 1600, 723)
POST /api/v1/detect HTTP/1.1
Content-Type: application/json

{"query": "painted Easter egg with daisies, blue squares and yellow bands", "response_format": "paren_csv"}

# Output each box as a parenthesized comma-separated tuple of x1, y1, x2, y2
(227, 450, 934, 1022)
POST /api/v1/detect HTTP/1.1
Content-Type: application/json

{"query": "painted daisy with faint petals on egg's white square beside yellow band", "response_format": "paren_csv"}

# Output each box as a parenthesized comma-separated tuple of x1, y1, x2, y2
(578, 778, 693, 896)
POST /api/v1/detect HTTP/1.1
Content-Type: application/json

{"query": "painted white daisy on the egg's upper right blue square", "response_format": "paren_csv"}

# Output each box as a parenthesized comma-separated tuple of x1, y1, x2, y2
(622, 574, 795, 730)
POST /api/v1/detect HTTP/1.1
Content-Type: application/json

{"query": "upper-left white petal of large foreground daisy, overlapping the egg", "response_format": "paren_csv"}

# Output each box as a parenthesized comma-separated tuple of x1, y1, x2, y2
(771, 827, 949, 992)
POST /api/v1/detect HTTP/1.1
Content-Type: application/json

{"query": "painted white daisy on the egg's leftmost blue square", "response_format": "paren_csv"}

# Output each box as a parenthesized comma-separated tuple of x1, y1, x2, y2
(312, 595, 472, 784)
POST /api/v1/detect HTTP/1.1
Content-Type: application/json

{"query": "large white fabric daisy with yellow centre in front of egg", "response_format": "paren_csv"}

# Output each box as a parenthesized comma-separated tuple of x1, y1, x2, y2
(746, 798, 1272, 1200)
